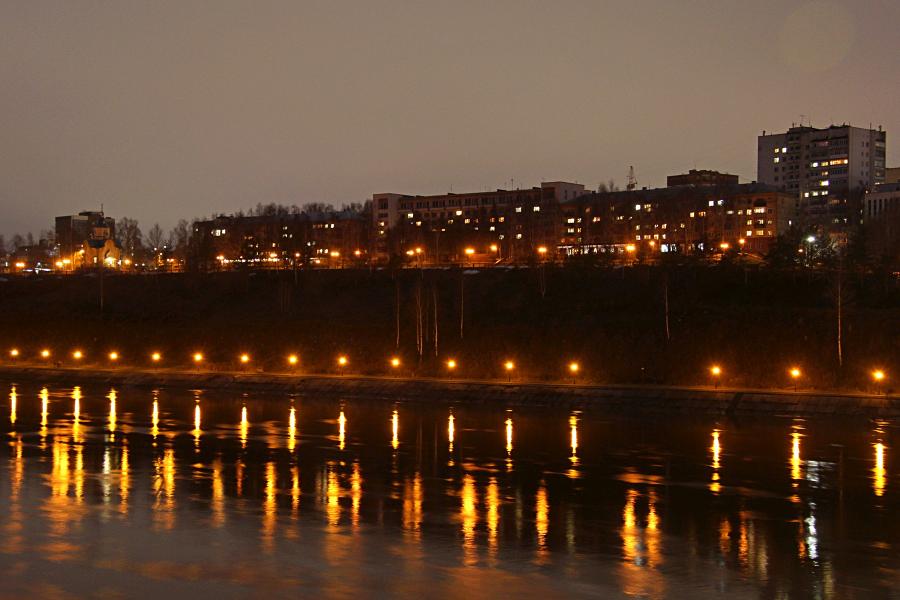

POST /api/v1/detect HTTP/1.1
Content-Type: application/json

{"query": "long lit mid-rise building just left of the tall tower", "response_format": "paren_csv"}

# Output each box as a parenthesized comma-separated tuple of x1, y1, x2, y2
(560, 183, 798, 257)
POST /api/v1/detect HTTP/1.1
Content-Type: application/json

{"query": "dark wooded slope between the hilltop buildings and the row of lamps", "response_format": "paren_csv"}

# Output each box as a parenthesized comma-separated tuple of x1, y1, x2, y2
(0, 265, 900, 393)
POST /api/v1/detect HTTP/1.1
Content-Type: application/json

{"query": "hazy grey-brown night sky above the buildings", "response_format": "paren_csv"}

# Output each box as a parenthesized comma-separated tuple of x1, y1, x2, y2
(0, 2, 900, 236)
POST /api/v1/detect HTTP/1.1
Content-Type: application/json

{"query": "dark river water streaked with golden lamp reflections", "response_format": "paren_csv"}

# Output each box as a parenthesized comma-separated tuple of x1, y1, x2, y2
(0, 383, 900, 598)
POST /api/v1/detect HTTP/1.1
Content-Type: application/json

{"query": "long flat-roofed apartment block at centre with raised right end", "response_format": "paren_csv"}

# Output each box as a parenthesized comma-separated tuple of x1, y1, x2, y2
(372, 181, 584, 263)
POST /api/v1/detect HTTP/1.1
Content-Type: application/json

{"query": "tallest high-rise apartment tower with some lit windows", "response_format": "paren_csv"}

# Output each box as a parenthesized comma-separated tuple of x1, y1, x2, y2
(756, 125, 887, 234)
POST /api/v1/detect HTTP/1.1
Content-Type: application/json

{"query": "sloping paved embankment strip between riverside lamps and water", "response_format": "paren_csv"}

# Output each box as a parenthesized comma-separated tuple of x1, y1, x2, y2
(0, 366, 900, 418)
